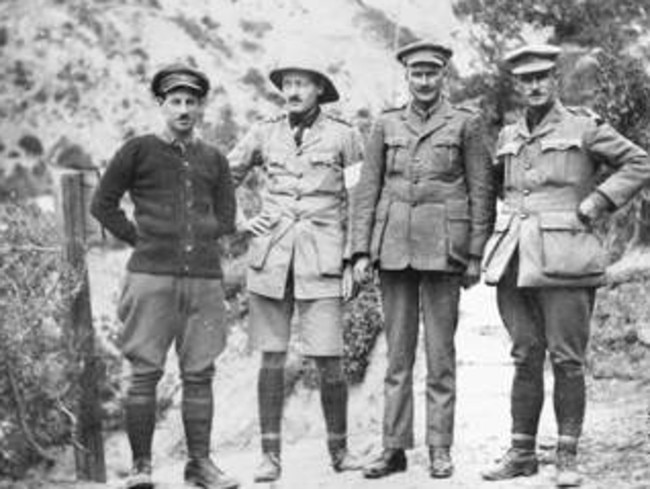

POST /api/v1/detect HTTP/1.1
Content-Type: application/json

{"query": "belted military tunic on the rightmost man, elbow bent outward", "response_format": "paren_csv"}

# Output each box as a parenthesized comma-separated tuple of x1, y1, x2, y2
(484, 102, 650, 287)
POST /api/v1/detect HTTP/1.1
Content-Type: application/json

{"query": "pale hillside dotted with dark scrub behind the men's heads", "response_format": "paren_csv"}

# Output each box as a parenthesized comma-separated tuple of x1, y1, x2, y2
(0, 0, 471, 178)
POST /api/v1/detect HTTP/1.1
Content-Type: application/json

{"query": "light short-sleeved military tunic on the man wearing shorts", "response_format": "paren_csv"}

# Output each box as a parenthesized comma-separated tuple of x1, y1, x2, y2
(229, 113, 363, 300)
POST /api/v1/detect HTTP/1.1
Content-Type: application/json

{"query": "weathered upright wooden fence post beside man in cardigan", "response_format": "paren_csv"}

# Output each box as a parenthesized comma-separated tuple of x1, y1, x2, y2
(60, 171, 106, 482)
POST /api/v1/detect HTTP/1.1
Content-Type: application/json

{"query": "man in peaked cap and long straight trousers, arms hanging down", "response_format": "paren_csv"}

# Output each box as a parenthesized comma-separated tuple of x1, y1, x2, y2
(352, 41, 494, 478)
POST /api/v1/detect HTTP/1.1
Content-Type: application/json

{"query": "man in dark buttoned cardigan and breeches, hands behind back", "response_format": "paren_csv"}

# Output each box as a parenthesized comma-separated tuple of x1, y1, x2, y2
(92, 65, 239, 489)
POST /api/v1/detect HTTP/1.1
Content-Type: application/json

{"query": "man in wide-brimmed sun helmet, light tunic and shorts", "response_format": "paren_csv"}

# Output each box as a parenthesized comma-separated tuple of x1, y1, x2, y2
(230, 52, 362, 485)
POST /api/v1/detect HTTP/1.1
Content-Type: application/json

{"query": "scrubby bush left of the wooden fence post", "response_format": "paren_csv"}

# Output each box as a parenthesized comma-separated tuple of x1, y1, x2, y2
(0, 203, 119, 478)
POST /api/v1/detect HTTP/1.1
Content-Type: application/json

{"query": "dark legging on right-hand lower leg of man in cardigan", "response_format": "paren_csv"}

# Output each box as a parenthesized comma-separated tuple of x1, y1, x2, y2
(182, 379, 214, 459)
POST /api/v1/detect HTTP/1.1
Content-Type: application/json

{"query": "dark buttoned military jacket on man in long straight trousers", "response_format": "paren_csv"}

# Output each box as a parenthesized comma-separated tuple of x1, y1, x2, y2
(352, 99, 494, 266)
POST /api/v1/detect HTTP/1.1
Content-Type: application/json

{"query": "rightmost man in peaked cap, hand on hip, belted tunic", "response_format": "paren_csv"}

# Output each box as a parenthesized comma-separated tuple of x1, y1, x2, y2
(483, 44, 650, 487)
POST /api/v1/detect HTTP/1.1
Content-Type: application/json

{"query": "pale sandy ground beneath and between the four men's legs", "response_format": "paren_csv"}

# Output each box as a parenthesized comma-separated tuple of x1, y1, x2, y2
(11, 255, 650, 489)
